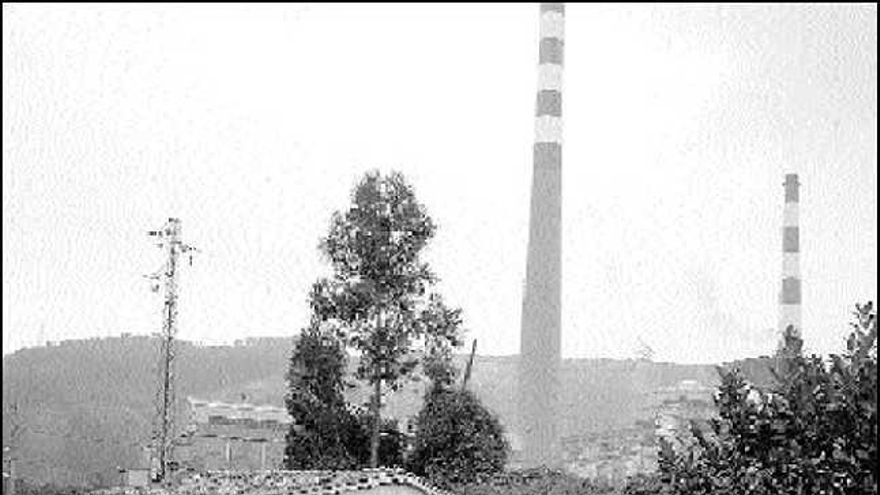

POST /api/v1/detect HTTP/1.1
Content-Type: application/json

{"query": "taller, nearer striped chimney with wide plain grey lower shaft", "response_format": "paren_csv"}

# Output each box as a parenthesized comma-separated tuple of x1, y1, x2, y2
(519, 3, 565, 466)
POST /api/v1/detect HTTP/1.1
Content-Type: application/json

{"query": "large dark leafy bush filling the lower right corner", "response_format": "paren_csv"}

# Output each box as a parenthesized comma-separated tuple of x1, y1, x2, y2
(658, 303, 877, 495)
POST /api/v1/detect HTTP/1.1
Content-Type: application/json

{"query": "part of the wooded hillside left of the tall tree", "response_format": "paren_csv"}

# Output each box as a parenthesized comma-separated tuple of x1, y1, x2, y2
(3, 337, 293, 484)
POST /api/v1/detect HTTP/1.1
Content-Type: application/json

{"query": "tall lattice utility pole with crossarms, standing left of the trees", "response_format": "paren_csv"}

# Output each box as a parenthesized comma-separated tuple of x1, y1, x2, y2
(147, 218, 198, 483)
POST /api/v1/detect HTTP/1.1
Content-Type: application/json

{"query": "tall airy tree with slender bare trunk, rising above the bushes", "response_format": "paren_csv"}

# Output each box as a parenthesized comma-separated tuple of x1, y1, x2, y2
(312, 171, 458, 466)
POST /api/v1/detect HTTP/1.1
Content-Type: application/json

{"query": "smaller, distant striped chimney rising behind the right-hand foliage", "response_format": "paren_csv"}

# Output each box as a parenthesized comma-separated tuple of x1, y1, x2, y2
(779, 174, 801, 344)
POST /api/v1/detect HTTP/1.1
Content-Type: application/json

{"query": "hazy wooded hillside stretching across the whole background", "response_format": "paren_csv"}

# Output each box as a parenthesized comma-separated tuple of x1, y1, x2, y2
(3, 337, 736, 484)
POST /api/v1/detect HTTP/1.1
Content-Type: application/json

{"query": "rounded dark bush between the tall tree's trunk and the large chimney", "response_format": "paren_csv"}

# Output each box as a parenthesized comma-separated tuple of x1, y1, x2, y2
(408, 388, 509, 488)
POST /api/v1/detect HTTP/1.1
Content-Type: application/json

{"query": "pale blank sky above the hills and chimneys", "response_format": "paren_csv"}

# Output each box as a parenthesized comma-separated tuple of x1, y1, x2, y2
(2, 4, 877, 363)
